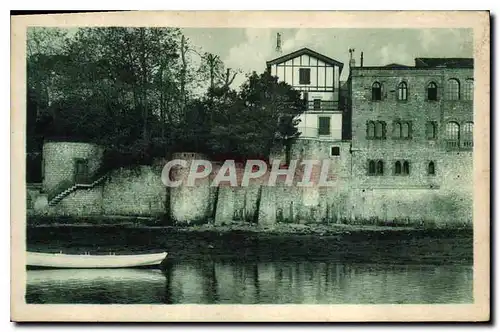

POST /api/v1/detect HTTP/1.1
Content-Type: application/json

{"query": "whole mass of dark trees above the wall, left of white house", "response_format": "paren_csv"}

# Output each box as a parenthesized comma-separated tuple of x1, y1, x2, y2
(27, 27, 303, 179)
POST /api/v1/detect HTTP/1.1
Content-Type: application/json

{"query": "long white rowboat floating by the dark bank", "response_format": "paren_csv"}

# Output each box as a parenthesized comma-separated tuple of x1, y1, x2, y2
(26, 252, 167, 269)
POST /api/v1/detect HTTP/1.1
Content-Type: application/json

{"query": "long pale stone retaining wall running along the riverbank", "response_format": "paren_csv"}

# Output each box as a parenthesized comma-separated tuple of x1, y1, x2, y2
(27, 139, 472, 226)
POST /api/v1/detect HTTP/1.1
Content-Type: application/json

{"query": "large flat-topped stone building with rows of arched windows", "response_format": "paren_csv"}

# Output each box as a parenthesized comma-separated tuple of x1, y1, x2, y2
(348, 58, 474, 221)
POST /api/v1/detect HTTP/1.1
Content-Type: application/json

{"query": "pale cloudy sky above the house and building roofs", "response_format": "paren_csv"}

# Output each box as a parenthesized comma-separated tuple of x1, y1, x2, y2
(182, 28, 473, 87)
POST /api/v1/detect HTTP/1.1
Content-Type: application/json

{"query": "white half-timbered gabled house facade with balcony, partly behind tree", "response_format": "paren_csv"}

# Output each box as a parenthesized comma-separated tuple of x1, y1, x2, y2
(267, 48, 344, 140)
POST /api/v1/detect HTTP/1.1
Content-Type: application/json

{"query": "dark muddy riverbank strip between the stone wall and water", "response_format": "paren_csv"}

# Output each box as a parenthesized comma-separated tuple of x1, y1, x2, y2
(27, 220, 473, 264)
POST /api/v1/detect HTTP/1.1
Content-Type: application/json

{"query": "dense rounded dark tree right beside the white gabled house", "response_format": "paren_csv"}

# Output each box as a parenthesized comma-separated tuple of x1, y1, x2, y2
(184, 72, 305, 160)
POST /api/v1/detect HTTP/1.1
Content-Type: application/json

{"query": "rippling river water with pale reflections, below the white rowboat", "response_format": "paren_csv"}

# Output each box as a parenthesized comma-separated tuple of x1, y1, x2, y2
(26, 261, 472, 304)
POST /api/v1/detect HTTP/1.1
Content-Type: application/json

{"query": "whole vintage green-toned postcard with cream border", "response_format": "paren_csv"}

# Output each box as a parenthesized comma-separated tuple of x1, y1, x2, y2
(11, 11, 490, 322)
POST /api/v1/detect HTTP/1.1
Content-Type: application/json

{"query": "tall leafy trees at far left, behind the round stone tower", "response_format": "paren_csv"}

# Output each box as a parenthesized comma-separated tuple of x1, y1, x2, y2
(27, 27, 203, 169)
